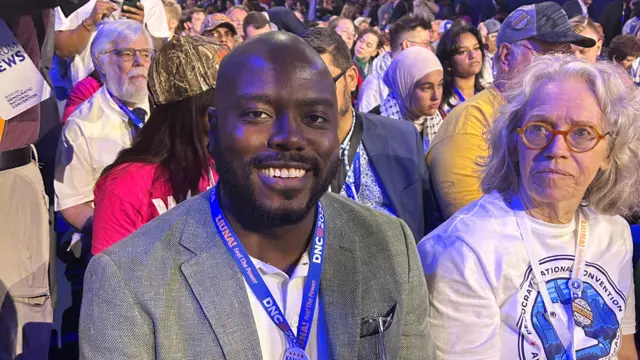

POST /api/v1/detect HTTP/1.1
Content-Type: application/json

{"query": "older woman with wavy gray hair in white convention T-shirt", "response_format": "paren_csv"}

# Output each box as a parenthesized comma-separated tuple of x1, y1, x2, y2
(418, 56, 640, 360)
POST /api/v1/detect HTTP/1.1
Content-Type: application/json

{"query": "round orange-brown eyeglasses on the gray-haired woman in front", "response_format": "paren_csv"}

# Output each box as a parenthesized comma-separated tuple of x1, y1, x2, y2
(518, 122, 611, 153)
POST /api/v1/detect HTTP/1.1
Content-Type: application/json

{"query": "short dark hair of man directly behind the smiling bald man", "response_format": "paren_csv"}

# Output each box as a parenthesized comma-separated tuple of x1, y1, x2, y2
(298, 27, 353, 71)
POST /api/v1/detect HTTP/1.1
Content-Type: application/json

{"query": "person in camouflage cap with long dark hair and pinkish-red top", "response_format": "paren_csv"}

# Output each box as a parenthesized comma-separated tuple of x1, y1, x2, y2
(91, 36, 228, 255)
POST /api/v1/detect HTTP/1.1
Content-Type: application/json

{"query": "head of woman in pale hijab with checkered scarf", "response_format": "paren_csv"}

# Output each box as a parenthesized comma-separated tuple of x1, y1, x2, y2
(372, 46, 444, 152)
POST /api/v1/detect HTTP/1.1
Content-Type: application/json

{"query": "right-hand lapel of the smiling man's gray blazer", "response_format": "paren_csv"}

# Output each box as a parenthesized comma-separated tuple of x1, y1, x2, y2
(318, 195, 361, 359)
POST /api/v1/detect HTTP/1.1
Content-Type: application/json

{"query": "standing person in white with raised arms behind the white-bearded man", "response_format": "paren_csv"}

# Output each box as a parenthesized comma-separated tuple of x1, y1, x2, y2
(55, 0, 171, 85)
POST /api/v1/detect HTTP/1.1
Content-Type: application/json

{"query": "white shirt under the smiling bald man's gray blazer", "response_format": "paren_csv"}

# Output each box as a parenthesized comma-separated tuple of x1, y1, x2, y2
(244, 252, 326, 360)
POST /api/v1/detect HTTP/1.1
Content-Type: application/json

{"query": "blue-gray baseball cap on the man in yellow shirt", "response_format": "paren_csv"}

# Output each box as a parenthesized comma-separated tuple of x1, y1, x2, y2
(496, 1, 596, 48)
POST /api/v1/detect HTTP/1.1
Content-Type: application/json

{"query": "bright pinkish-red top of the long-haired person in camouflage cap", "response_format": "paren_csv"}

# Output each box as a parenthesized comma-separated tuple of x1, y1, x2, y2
(91, 163, 218, 255)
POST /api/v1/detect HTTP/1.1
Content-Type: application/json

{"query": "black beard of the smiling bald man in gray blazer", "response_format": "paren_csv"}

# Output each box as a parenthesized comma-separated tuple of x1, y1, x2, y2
(211, 132, 340, 228)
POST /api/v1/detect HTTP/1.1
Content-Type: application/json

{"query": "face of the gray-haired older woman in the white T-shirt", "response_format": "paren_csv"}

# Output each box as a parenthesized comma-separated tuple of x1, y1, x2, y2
(516, 78, 609, 210)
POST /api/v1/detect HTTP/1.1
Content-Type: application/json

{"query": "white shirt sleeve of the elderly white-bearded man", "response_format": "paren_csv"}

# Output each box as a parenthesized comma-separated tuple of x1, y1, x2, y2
(53, 121, 95, 211)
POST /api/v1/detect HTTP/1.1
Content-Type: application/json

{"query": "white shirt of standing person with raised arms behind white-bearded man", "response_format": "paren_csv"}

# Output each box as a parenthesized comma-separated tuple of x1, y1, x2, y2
(55, 0, 171, 85)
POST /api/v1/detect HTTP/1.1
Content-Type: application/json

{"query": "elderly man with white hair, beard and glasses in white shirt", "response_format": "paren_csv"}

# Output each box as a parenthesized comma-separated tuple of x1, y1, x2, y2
(54, 20, 154, 247)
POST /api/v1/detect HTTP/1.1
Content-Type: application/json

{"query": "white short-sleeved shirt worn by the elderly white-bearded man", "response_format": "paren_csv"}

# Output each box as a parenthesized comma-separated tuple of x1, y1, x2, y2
(54, 86, 149, 211)
